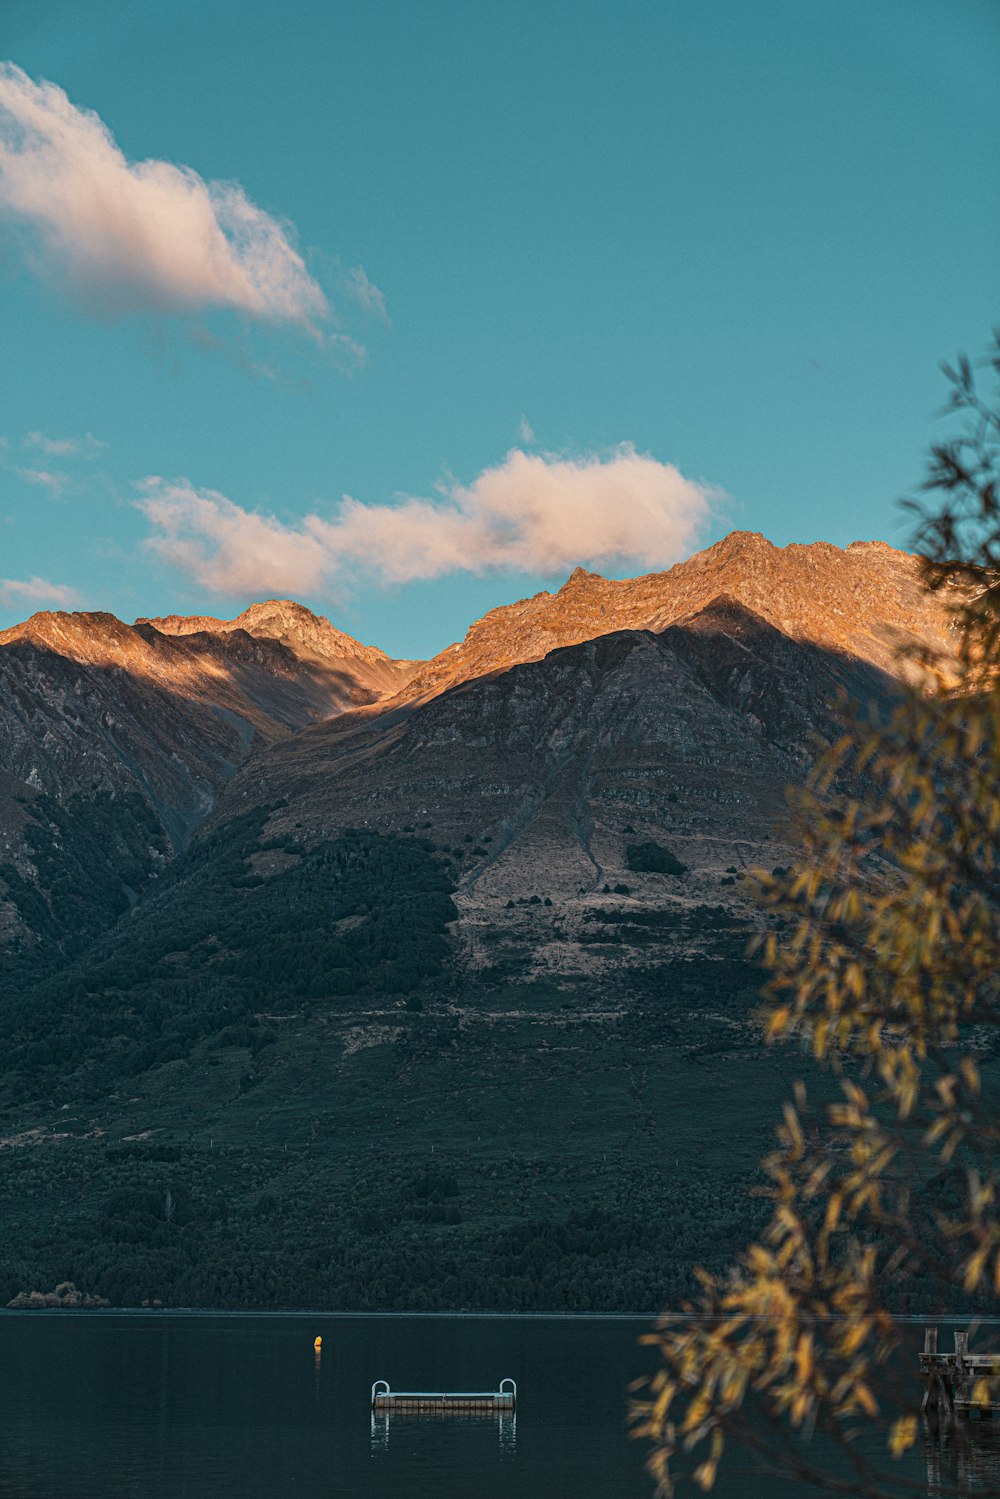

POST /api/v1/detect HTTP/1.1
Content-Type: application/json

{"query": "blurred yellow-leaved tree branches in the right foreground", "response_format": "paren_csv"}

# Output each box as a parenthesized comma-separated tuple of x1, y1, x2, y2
(639, 337, 1000, 1495)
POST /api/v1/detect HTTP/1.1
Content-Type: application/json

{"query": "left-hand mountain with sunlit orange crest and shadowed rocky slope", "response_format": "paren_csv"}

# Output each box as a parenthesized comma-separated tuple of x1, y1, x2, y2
(0, 604, 405, 941)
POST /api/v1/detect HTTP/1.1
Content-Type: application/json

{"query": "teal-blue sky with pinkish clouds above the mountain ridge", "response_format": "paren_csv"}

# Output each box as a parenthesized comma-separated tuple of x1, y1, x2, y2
(0, 0, 1000, 657)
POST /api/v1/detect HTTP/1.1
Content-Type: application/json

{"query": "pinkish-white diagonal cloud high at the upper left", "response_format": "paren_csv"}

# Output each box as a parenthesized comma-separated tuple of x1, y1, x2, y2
(0, 63, 328, 333)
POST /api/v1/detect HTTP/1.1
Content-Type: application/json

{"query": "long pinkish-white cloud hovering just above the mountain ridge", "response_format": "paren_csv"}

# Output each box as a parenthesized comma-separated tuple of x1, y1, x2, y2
(138, 445, 714, 595)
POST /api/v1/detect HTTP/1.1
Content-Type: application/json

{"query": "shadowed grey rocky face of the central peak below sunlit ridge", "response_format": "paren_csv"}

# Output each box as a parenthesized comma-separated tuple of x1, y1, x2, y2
(210, 597, 895, 974)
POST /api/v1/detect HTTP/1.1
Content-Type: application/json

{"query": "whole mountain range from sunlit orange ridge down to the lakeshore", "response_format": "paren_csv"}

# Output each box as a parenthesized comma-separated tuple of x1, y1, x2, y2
(0, 532, 952, 1309)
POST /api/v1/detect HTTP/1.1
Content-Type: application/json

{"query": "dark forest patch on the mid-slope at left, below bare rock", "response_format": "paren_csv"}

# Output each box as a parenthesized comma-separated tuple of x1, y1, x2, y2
(0, 808, 456, 1097)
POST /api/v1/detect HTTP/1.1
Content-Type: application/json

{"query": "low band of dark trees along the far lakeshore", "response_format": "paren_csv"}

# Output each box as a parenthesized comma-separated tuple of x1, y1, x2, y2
(0, 1127, 760, 1312)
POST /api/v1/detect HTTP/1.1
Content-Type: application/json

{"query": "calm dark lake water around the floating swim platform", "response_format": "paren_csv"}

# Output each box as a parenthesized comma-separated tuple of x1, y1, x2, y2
(0, 1312, 1000, 1499)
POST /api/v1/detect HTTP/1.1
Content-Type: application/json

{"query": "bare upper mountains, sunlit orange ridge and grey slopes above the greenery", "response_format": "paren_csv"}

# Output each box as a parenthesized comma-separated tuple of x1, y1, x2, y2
(0, 532, 949, 941)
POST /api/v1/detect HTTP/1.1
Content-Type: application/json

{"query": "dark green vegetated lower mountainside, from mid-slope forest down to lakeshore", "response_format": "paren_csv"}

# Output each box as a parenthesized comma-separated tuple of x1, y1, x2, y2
(0, 761, 797, 1310)
